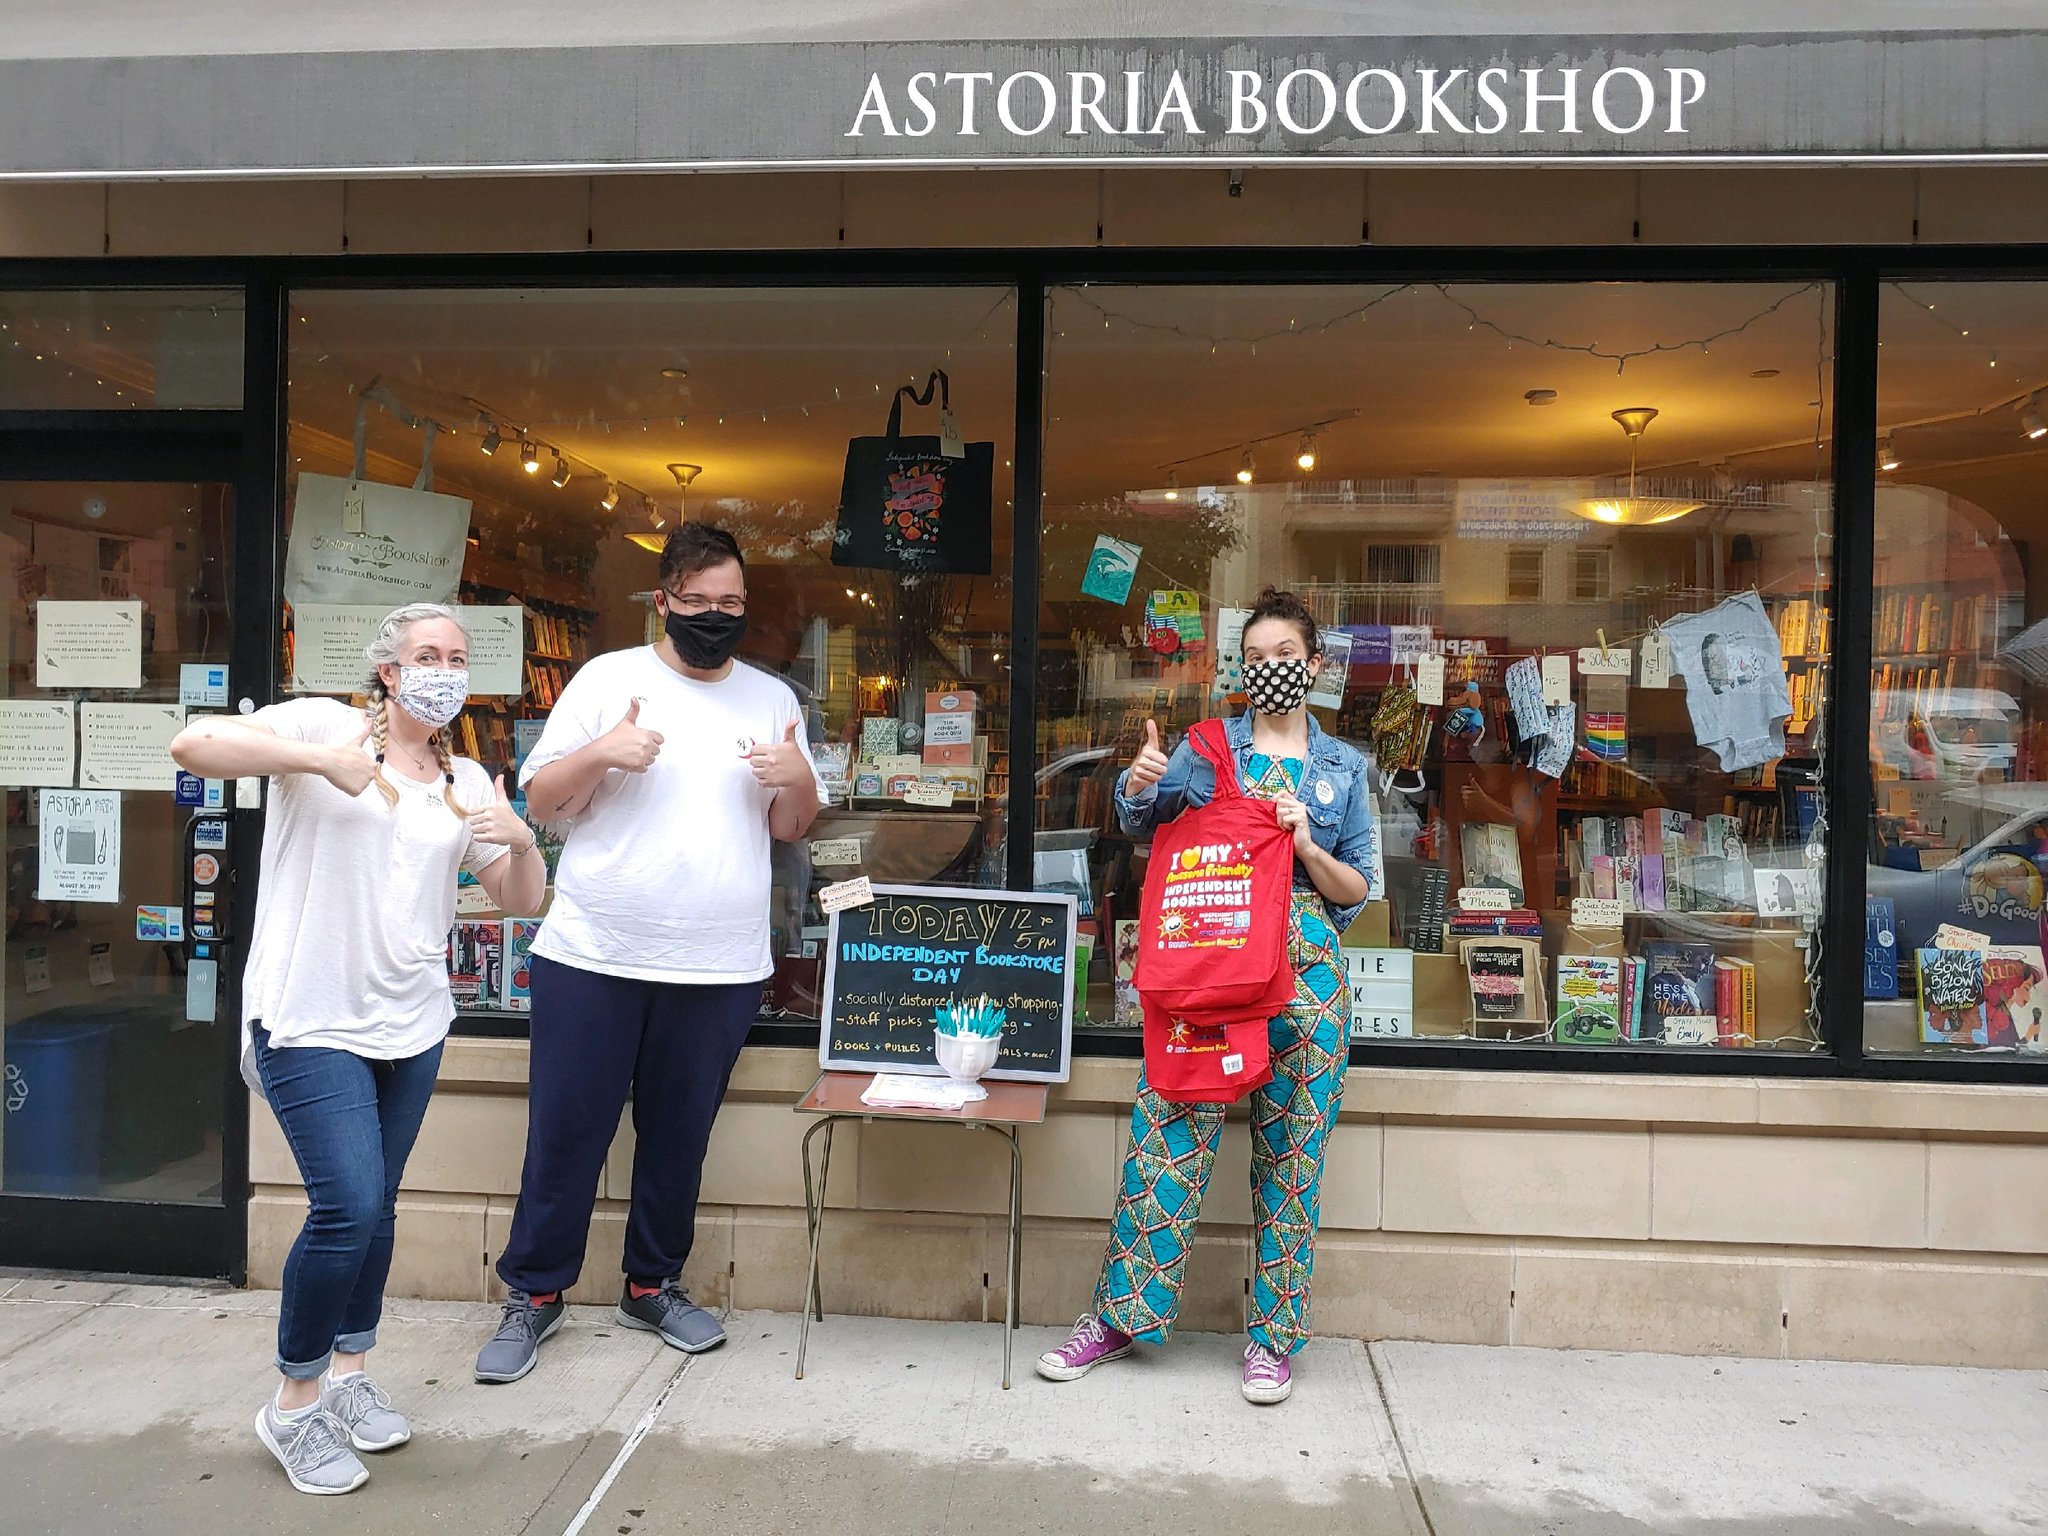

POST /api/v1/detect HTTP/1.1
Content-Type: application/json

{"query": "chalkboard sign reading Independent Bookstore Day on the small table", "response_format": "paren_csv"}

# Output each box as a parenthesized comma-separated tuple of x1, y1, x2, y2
(817, 885, 1073, 1083)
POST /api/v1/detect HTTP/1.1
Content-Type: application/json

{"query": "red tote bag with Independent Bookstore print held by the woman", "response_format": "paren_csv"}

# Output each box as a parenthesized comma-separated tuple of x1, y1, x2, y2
(1133, 721, 1294, 1104)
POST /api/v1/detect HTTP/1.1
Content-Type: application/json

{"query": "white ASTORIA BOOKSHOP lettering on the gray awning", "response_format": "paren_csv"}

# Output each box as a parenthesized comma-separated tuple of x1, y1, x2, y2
(846, 63, 1708, 145)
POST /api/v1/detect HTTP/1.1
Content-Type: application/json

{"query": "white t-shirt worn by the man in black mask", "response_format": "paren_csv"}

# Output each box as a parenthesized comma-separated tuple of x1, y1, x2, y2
(520, 645, 829, 985)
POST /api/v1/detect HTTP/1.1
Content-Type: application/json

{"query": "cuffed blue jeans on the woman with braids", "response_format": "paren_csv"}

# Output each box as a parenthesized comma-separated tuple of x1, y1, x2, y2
(250, 1024, 440, 1380)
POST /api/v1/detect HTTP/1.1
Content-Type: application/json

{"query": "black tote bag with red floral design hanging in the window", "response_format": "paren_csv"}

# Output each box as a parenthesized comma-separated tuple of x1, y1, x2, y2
(831, 373, 995, 575)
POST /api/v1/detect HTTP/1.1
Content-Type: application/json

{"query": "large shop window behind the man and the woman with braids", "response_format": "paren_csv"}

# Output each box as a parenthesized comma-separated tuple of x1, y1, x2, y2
(285, 287, 1016, 1036)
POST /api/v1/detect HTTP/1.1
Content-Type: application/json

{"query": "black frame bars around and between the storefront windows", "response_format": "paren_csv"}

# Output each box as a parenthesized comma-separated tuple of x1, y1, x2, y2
(0, 244, 2048, 1081)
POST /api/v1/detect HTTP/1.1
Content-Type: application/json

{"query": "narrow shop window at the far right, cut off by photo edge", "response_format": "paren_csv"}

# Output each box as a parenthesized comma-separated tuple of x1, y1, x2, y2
(1864, 281, 2048, 1055)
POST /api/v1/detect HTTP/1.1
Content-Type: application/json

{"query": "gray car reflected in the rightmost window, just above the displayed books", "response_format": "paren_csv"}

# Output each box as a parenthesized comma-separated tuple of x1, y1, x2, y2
(1866, 784, 2048, 946)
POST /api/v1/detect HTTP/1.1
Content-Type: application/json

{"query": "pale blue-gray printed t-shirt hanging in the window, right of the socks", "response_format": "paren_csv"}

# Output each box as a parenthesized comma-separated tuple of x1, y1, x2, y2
(1661, 592, 1792, 774)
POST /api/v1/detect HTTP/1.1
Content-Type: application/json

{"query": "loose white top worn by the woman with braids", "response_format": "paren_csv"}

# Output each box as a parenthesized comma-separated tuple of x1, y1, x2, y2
(242, 698, 512, 1061)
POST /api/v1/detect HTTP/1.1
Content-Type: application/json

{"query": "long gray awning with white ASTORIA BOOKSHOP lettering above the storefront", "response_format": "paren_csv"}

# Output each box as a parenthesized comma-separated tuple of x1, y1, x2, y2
(0, 0, 2048, 178)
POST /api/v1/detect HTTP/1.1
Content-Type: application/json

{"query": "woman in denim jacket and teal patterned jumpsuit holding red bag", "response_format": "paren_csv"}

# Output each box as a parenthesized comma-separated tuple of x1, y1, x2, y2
(1038, 588, 1378, 1403)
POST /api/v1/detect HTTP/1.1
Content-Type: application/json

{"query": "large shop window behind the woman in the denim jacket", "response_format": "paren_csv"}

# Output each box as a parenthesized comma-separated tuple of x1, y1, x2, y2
(1036, 283, 1835, 1051)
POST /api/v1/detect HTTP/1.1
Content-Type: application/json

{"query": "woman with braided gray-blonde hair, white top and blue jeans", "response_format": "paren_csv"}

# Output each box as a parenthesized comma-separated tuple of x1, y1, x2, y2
(170, 602, 547, 1493)
